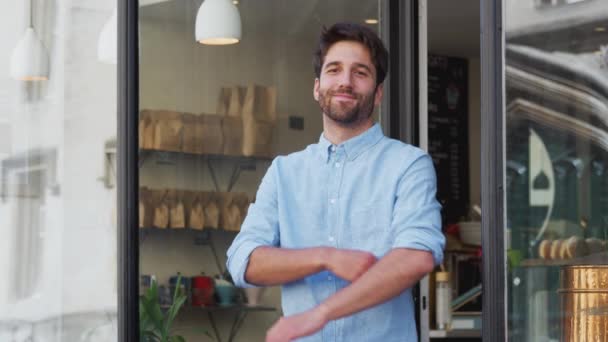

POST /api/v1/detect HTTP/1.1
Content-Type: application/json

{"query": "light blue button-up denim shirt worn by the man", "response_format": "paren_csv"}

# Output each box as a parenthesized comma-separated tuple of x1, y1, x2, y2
(227, 124, 445, 342)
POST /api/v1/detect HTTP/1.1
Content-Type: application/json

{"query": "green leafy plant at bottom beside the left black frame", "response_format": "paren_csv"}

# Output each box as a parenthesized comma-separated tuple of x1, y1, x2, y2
(139, 276, 187, 342)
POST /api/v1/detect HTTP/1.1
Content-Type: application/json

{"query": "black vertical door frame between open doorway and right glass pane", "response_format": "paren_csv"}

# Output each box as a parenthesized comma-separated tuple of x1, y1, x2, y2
(480, 0, 508, 342)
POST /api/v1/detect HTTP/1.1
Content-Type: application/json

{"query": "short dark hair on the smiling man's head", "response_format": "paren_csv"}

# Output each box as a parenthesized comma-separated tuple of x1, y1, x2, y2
(313, 23, 388, 86)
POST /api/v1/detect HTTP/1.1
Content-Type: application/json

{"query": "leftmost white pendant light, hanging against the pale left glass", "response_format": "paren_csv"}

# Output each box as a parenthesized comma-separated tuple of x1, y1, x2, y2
(10, 0, 49, 81)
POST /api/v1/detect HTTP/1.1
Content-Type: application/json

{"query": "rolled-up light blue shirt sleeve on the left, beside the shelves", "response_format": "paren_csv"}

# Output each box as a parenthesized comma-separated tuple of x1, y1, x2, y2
(226, 159, 279, 287)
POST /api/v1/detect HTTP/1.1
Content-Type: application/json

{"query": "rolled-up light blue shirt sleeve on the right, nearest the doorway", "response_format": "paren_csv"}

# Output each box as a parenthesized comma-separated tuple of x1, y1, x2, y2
(391, 154, 445, 265)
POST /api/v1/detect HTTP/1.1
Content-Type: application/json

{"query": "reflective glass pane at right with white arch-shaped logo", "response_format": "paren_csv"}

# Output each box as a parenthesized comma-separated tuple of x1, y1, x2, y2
(505, 0, 608, 341)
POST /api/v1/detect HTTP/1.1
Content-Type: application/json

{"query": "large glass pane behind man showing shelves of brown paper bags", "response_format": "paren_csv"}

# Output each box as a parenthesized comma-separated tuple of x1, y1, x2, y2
(137, 0, 382, 341)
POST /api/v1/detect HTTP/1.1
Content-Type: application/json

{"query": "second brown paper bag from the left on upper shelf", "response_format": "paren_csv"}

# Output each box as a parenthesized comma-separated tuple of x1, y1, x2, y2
(154, 111, 183, 151)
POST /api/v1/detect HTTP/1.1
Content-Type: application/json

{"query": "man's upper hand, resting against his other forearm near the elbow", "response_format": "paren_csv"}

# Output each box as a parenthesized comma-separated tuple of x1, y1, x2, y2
(325, 249, 377, 282)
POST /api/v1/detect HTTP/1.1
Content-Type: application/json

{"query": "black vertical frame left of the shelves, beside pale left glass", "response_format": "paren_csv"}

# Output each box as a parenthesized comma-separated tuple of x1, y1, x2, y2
(116, 0, 139, 342)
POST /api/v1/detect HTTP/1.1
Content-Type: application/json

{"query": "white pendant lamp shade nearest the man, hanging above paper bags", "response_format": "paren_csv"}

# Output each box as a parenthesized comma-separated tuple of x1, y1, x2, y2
(195, 0, 241, 45)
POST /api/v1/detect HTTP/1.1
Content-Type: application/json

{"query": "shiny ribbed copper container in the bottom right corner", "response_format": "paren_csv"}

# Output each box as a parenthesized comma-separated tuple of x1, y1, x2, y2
(558, 265, 608, 342)
